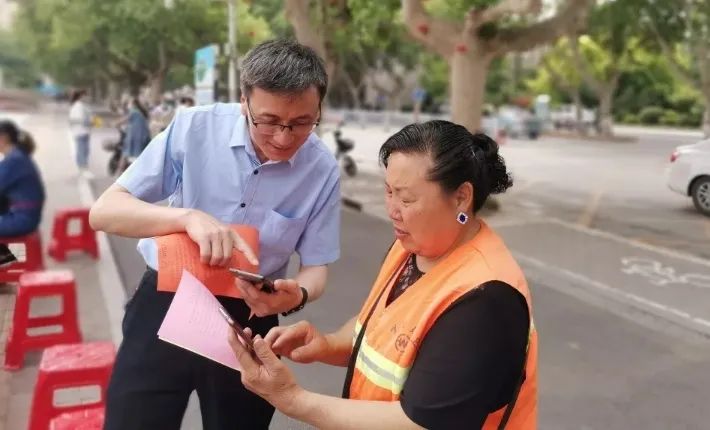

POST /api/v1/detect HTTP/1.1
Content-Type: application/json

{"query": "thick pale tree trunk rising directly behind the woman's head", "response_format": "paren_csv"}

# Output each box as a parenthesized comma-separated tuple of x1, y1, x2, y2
(451, 50, 490, 133)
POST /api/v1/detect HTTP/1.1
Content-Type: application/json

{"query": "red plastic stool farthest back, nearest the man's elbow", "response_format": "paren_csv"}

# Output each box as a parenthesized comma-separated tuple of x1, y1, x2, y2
(49, 208, 99, 261)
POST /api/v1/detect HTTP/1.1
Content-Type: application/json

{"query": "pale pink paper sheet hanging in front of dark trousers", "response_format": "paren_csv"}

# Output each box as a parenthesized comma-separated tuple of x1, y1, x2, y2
(158, 270, 241, 370)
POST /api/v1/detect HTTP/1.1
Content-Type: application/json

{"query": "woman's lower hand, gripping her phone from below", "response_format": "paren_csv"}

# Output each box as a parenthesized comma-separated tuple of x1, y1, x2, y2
(229, 328, 304, 413)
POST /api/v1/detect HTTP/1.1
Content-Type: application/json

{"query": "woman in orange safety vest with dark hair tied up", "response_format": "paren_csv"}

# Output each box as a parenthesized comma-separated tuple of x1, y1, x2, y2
(230, 121, 537, 430)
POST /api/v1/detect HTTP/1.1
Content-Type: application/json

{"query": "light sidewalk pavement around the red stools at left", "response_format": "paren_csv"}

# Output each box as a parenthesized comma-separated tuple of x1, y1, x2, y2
(0, 105, 124, 430)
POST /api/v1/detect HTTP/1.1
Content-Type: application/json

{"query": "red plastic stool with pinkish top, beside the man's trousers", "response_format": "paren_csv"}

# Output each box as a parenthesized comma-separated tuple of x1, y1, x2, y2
(29, 342, 116, 430)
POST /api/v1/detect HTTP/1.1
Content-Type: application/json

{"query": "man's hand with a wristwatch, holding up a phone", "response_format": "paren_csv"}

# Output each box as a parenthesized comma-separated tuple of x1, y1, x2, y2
(235, 279, 303, 317)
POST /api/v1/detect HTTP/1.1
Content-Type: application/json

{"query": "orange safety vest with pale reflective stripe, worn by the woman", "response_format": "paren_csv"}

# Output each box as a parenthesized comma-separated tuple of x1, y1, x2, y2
(346, 222, 537, 430)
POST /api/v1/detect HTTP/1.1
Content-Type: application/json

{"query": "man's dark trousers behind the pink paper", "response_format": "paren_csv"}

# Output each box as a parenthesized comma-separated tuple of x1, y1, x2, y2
(104, 268, 278, 430)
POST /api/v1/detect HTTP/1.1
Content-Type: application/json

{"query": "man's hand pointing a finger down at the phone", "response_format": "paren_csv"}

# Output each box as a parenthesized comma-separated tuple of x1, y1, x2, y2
(185, 210, 259, 266)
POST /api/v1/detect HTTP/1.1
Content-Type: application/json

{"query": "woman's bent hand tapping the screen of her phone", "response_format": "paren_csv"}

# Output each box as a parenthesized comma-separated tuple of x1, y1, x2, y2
(264, 321, 330, 363)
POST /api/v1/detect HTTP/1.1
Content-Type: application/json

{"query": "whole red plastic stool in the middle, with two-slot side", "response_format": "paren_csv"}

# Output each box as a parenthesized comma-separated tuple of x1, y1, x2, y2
(5, 270, 81, 370)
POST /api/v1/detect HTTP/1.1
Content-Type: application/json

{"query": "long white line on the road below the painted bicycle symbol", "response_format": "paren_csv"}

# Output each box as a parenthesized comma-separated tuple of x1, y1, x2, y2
(514, 252, 710, 334)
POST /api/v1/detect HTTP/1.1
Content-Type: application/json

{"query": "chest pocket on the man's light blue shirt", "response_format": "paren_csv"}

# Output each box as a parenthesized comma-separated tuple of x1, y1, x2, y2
(259, 210, 306, 257)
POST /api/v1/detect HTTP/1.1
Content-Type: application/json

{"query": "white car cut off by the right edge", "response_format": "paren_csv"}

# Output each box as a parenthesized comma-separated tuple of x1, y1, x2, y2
(668, 140, 710, 216)
